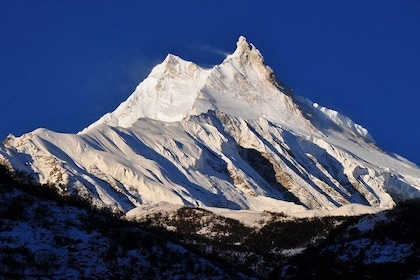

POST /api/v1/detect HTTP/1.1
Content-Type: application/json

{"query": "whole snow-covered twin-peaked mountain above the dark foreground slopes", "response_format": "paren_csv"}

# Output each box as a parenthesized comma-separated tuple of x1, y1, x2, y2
(0, 37, 420, 213)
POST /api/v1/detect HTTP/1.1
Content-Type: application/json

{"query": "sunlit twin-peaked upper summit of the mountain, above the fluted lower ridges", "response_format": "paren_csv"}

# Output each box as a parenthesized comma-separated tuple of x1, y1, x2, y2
(83, 36, 296, 130)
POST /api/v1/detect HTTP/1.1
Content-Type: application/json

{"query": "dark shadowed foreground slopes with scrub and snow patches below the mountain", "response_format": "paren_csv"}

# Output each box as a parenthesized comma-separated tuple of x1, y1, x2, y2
(0, 168, 420, 279)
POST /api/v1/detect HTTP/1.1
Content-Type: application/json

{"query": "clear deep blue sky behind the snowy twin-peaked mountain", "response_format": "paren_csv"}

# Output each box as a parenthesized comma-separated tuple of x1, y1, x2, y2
(0, 0, 420, 164)
